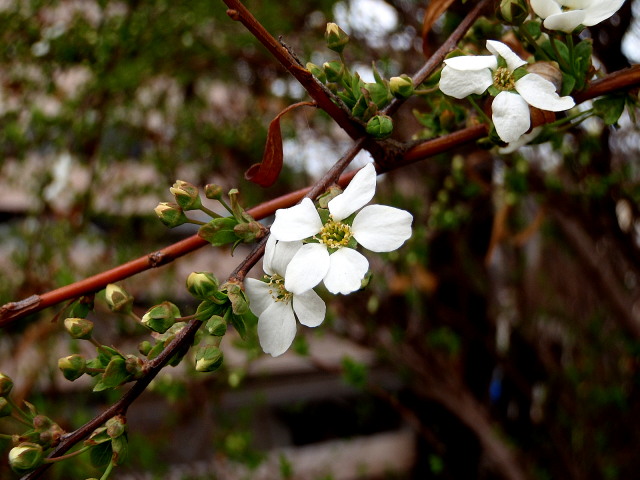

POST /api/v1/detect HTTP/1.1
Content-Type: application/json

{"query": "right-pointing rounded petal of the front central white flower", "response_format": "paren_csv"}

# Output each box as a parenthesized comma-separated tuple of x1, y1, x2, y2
(351, 205, 413, 252)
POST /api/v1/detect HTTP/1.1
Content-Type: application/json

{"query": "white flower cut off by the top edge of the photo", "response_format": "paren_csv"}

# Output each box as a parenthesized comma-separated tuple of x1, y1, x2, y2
(531, 0, 624, 33)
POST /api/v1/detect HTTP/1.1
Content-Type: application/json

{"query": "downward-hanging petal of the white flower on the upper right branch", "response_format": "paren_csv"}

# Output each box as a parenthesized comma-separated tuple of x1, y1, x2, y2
(491, 92, 531, 143)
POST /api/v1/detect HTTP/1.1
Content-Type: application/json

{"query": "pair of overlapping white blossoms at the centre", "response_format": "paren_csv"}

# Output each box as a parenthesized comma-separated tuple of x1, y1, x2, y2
(244, 164, 413, 357)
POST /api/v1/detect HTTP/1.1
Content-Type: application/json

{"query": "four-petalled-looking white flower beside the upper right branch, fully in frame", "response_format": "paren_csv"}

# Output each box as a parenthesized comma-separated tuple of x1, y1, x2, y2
(440, 40, 575, 143)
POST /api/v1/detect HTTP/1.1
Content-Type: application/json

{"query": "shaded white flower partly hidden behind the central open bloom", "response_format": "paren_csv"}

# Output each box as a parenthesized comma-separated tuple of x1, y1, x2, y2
(244, 235, 327, 357)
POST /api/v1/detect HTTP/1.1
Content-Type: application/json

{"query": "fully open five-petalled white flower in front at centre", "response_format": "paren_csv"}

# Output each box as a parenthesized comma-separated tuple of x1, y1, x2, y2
(271, 164, 413, 294)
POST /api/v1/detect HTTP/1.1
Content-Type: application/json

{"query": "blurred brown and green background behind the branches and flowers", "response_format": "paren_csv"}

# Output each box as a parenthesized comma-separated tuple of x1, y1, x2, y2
(0, 0, 640, 480)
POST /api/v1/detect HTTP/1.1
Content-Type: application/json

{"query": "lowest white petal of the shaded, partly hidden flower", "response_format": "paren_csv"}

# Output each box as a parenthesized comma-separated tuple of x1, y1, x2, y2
(258, 302, 296, 357)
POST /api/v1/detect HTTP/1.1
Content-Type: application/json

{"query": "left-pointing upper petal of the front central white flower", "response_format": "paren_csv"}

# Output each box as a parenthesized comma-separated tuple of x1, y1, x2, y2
(271, 198, 322, 242)
